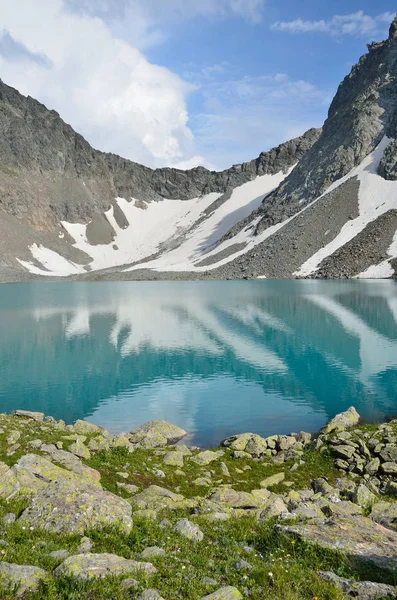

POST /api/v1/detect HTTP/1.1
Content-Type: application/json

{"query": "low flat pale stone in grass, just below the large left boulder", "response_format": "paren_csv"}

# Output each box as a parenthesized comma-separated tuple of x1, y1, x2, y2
(53, 554, 157, 581)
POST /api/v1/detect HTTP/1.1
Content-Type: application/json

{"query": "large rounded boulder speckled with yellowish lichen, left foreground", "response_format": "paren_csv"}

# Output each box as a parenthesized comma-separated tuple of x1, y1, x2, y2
(19, 481, 132, 533)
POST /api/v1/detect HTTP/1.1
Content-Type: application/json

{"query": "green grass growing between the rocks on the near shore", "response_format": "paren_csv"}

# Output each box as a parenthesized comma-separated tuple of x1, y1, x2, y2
(0, 417, 397, 600)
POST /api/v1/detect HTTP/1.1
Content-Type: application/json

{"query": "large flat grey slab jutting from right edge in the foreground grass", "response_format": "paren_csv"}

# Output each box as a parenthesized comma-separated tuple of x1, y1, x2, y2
(275, 505, 397, 573)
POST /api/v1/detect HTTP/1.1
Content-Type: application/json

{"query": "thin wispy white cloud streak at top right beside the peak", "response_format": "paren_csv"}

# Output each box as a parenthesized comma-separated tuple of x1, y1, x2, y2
(271, 10, 395, 36)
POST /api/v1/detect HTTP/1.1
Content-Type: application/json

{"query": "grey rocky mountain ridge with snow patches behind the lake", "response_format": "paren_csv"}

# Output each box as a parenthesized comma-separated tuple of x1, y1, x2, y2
(0, 17, 397, 280)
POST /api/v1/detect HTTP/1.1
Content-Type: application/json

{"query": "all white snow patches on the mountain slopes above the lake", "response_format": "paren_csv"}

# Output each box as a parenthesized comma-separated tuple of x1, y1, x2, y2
(14, 137, 397, 279)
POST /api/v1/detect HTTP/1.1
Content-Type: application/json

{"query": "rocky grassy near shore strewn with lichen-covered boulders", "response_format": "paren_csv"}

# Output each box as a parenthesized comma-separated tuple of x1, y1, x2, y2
(0, 408, 397, 600)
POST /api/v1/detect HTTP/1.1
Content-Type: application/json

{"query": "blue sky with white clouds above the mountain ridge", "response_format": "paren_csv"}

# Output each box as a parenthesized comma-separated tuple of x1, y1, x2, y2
(0, 0, 396, 169)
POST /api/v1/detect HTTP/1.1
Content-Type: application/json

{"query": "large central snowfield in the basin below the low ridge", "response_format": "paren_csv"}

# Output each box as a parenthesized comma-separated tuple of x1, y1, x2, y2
(17, 170, 291, 277)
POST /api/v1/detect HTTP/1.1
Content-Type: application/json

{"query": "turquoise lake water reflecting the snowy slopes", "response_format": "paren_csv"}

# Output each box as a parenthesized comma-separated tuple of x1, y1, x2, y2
(0, 281, 397, 446)
